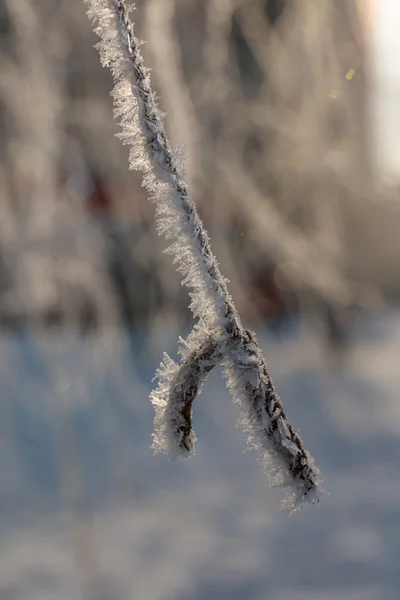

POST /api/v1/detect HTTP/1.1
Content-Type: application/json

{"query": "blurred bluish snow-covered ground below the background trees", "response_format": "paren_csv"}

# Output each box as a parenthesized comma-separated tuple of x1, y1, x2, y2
(0, 314, 400, 600)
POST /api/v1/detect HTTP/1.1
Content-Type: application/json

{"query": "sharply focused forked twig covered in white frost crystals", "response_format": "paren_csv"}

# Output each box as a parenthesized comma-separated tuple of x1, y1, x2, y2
(84, 0, 319, 510)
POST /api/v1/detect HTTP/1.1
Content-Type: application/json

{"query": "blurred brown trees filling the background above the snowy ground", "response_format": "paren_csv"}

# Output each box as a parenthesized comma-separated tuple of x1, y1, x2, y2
(0, 0, 400, 340)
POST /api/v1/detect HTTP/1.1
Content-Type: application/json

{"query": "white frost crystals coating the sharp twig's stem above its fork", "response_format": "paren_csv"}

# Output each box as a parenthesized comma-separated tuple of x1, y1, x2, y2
(85, 0, 227, 327)
